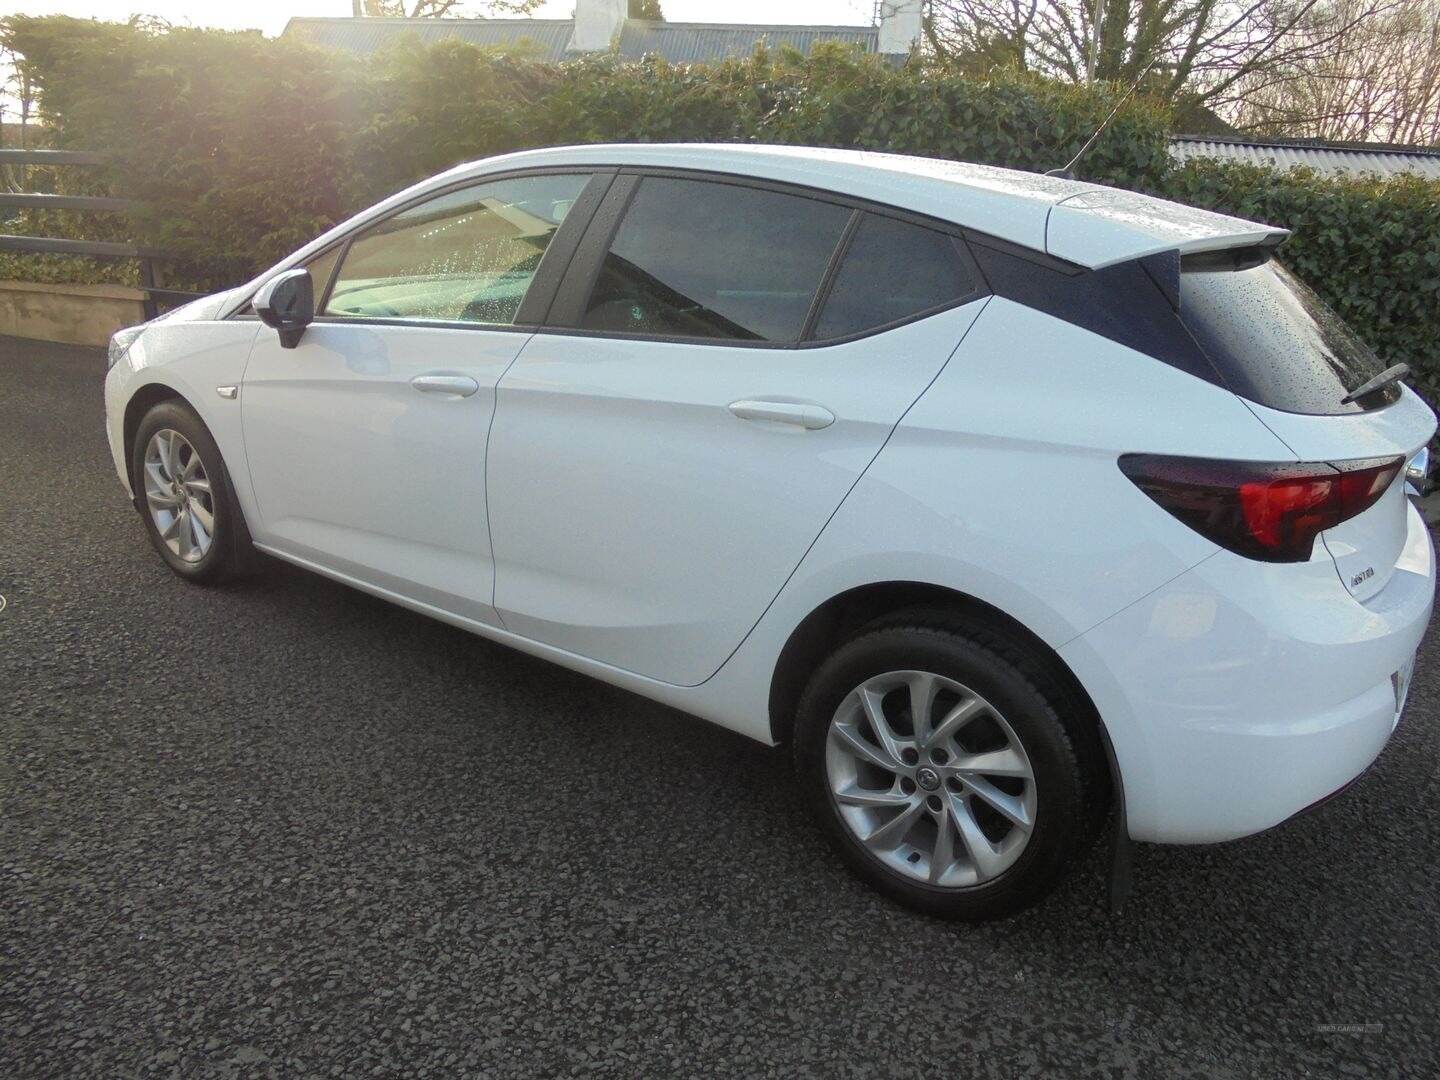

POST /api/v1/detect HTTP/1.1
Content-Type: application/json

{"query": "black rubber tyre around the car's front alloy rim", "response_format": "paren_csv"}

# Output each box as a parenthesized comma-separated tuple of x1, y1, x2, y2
(130, 399, 255, 585)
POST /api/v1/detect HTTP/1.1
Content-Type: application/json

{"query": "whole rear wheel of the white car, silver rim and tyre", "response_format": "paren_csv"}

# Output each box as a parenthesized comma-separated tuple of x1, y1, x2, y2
(795, 615, 1106, 920)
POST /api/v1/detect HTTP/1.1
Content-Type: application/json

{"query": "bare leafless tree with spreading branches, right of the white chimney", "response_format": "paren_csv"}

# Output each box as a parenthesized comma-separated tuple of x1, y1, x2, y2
(924, 0, 1403, 112)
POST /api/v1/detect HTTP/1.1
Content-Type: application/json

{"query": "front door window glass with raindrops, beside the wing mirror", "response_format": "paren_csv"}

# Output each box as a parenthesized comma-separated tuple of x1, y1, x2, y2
(325, 174, 589, 325)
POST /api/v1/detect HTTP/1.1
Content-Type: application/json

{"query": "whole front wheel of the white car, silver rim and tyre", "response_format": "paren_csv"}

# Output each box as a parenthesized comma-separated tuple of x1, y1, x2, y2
(131, 400, 251, 583)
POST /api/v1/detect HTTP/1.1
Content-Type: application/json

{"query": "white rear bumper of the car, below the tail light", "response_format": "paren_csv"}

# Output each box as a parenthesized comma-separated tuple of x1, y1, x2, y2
(1061, 507, 1436, 844)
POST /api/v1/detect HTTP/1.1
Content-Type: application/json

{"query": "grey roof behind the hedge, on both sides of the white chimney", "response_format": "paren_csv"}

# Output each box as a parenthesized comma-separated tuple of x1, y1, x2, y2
(275, 17, 880, 63)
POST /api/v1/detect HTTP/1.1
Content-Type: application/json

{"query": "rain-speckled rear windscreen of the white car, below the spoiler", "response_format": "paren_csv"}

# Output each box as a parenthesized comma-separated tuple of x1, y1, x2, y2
(1179, 249, 1400, 415)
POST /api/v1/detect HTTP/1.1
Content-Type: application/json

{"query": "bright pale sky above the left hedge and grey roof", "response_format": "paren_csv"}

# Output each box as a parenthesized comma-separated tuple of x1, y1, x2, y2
(0, 0, 874, 35)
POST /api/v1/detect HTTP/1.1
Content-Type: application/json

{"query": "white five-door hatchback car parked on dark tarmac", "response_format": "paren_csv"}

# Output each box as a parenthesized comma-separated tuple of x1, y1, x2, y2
(105, 145, 1436, 919)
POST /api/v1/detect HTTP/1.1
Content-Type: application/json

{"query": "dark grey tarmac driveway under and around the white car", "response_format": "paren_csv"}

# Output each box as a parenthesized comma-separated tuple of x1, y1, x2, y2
(0, 338, 1440, 1077)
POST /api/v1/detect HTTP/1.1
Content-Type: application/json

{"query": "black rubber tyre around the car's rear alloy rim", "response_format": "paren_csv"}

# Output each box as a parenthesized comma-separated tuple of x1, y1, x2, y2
(793, 611, 1110, 922)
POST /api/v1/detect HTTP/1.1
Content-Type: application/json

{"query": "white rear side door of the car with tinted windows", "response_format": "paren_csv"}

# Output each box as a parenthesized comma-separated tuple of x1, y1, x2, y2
(488, 173, 982, 685)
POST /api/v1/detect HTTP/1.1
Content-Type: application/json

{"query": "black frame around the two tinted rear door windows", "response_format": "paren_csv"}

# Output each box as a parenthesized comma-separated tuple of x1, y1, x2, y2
(536, 166, 996, 351)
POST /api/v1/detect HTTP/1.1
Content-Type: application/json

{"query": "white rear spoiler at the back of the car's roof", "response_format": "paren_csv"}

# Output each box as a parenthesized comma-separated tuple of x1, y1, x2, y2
(1045, 187, 1290, 269)
